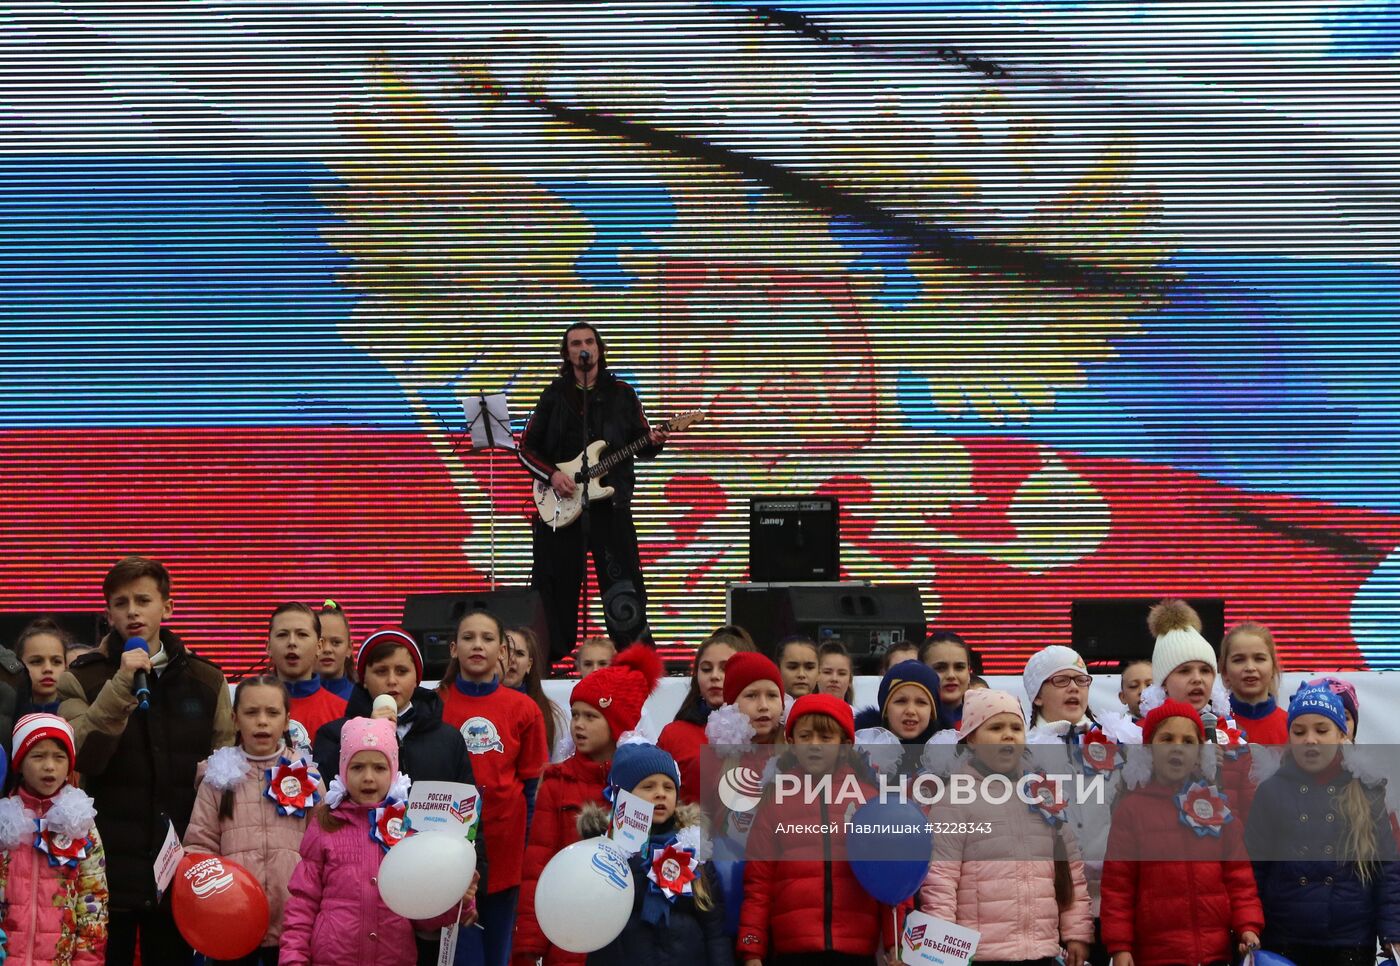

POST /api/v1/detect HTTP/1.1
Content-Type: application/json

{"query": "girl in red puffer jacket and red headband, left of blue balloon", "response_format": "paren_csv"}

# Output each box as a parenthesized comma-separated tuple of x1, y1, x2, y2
(736, 694, 897, 966)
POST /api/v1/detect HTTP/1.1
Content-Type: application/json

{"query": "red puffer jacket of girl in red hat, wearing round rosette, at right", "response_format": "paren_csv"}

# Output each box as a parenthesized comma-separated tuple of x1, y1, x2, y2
(1099, 781, 1264, 966)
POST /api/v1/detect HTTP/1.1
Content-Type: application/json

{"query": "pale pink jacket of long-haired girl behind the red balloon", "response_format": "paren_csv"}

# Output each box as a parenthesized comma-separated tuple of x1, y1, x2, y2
(185, 748, 325, 946)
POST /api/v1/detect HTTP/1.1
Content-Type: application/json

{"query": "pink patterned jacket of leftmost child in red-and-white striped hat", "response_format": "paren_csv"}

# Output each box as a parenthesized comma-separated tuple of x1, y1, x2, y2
(0, 788, 106, 966)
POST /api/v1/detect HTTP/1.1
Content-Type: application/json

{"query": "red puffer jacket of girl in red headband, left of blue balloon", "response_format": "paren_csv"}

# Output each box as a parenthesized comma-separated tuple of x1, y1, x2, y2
(735, 766, 909, 963)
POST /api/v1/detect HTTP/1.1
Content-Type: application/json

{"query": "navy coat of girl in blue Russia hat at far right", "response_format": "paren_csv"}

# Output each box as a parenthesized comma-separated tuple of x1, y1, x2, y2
(1245, 756, 1400, 949)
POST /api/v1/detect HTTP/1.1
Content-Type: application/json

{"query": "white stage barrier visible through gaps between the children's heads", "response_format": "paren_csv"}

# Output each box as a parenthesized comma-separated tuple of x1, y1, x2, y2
(545, 671, 1400, 745)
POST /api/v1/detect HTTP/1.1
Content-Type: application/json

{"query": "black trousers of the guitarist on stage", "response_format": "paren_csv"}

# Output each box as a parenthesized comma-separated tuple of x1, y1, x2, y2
(529, 500, 647, 661)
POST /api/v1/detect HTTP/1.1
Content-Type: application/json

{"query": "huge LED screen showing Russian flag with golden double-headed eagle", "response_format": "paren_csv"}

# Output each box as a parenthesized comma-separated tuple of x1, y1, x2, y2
(0, 0, 1400, 671)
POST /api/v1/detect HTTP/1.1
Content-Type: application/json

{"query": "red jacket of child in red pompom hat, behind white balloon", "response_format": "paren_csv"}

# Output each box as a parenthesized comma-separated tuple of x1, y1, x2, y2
(511, 753, 609, 966)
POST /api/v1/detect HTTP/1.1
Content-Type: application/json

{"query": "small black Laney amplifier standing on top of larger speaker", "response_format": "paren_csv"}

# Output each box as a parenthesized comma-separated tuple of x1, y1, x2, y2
(749, 497, 841, 582)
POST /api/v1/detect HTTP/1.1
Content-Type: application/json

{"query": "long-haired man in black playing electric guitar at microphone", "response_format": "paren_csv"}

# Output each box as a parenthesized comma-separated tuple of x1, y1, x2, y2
(519, 322, 668, 661)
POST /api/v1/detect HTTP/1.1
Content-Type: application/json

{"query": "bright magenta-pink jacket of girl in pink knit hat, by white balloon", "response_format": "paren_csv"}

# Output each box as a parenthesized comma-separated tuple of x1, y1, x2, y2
(279, 799, 456, 966)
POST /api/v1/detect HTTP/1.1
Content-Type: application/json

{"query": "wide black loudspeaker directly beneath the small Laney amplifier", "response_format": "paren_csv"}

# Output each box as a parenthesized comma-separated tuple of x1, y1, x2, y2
(729, 584, 927, 665)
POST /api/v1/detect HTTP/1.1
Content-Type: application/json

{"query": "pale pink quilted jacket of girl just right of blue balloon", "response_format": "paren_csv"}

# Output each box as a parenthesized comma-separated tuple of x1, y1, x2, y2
(918, 766, 1093, 960)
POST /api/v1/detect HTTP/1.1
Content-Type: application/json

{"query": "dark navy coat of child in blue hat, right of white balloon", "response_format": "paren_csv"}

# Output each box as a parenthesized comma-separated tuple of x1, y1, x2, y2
(588, 840, 734, 966)
